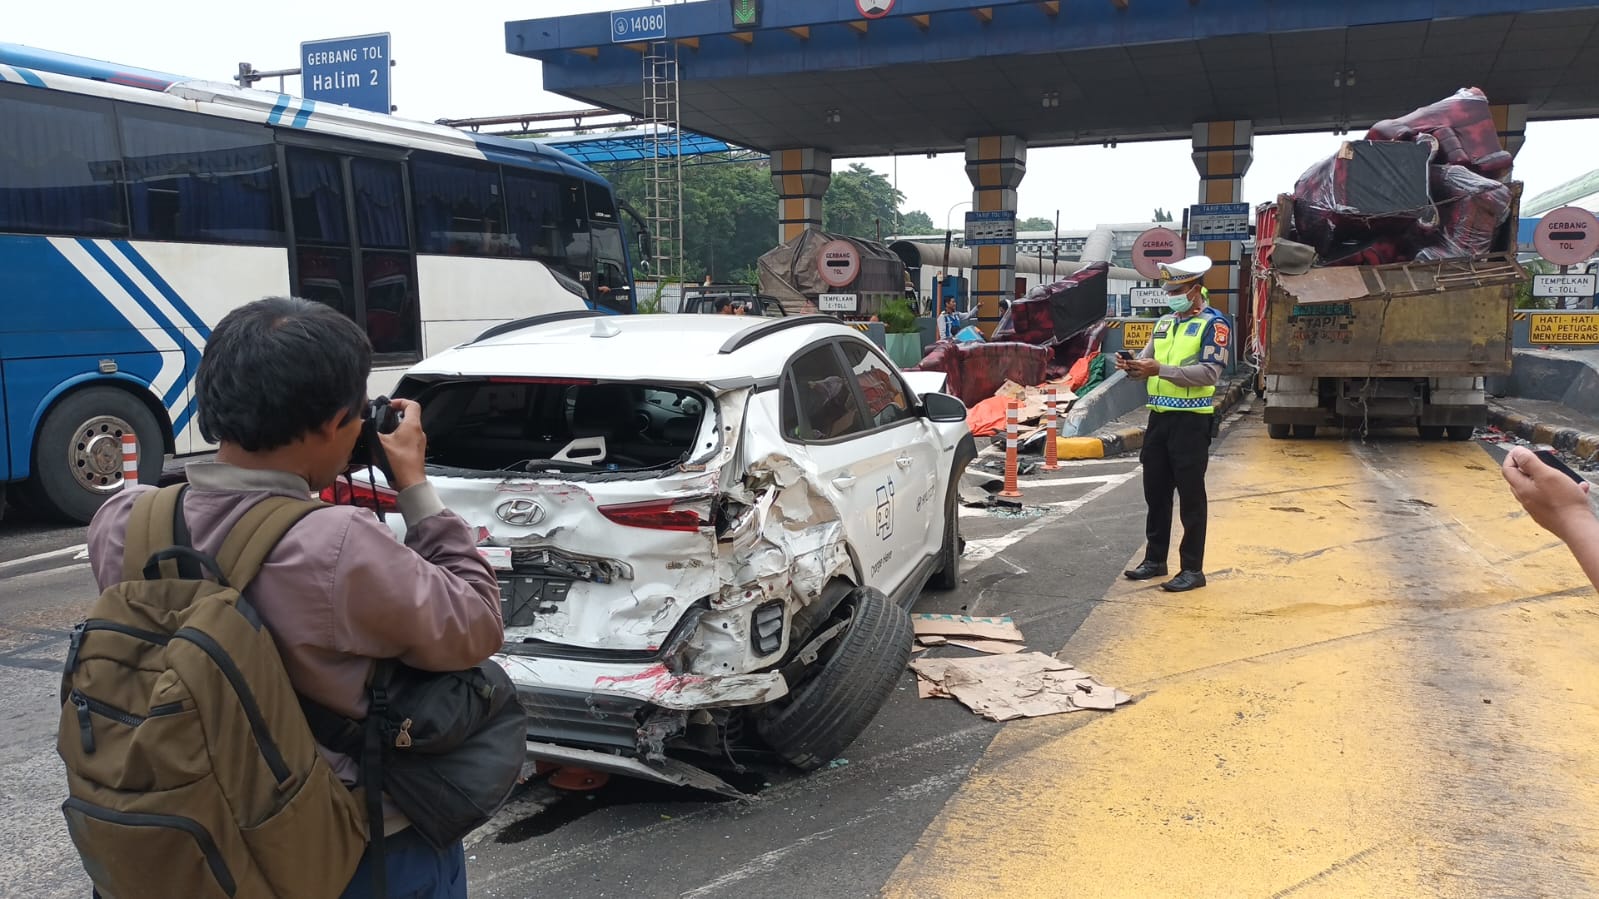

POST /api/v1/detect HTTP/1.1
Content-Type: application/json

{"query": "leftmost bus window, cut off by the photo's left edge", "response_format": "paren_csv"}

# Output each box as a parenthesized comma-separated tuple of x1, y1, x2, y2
(0, 85, 128, 237)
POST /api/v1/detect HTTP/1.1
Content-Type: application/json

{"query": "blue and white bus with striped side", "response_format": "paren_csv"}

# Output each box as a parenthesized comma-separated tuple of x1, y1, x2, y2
(0, 43, 635, 521)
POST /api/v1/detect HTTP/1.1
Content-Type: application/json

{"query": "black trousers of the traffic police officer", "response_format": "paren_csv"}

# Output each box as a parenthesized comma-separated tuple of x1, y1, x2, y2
(1138, 411, 1215, 571)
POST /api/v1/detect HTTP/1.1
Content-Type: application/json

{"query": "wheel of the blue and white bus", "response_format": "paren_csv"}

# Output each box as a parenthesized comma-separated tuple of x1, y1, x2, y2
(27, 387, 163, 523)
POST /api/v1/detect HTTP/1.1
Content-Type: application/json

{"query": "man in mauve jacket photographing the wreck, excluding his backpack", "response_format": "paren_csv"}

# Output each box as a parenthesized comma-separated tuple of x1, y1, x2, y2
(88, 298, 502, 897)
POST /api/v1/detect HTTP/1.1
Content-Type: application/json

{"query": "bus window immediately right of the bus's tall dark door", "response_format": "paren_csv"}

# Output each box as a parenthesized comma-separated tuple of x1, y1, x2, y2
(411, 154, 515, 256)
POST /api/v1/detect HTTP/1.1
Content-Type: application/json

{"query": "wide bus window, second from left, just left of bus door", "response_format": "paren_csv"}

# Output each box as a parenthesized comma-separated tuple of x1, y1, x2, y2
(117, 107, 283, 245)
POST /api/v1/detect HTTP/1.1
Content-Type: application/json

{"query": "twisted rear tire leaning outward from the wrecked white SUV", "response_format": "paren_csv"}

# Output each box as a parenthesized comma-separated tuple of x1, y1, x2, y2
(755, 587, 915, 771)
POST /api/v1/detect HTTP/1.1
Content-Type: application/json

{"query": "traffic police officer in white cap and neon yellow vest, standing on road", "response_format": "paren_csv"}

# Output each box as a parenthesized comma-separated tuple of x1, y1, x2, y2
(1116, 256, 1233, 592)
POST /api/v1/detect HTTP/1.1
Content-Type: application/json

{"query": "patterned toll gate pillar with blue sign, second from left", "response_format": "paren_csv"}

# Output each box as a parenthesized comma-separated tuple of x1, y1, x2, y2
(966, 136, 1027, 336)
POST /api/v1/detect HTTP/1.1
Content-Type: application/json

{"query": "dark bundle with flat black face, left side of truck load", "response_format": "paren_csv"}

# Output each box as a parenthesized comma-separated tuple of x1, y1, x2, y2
(1294, 139, 1438, 259)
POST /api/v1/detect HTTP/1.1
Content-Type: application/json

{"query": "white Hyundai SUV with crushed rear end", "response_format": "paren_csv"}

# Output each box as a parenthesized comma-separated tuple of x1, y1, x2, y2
(364, 312, 975, 789)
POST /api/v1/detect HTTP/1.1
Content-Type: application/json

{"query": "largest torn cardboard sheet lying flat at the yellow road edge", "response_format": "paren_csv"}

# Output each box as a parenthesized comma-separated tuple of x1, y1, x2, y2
(910, 653, 1132, 721)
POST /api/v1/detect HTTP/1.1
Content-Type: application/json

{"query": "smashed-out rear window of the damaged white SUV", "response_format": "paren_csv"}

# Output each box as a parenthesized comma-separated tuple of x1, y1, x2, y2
(413, 378, 710, 472)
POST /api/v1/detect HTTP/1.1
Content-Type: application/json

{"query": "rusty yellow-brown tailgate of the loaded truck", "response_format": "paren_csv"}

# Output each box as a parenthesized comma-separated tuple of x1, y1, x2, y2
(1262, 253, 1527, 378)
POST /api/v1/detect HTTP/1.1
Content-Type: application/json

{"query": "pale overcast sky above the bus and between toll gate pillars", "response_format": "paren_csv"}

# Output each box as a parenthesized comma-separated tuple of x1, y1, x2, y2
(12, 0, 1599, 230)
